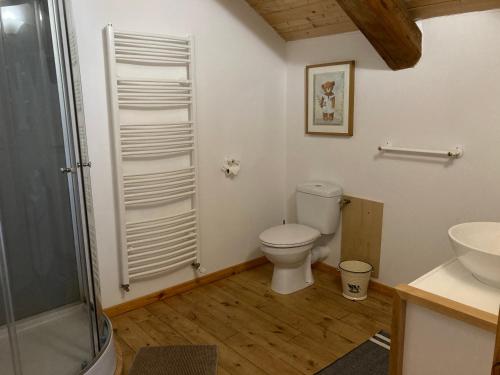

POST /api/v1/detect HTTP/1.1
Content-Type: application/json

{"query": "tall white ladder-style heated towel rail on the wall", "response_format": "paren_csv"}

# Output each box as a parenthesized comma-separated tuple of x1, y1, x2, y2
(106, 25, 200, 291)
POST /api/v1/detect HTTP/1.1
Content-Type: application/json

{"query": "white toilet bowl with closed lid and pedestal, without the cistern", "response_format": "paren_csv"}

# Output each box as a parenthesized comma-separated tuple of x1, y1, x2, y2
(259, 224, 321, 294)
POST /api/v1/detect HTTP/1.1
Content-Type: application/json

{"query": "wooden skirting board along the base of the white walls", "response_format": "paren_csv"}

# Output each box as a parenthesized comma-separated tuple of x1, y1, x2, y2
(104, 257, 394, 318)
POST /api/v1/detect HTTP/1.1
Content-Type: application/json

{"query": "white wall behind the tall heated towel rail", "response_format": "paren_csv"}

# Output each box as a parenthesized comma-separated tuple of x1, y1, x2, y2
(73, 0, 286, 307)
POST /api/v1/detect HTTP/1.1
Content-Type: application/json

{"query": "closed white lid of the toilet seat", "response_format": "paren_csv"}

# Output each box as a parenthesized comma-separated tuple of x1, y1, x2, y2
(259, 224, 321, 247)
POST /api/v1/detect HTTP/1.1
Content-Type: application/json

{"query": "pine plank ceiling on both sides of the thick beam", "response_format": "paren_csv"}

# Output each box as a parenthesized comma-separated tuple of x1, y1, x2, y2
(246, 0, 500, 41)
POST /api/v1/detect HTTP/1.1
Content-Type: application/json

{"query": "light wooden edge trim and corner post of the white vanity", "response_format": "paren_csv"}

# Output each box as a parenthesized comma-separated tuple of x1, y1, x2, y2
(389, 285, 497, 375)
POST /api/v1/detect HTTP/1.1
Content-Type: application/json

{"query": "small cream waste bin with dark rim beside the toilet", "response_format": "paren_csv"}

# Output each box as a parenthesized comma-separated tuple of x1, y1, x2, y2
(339, 260, 373, 301)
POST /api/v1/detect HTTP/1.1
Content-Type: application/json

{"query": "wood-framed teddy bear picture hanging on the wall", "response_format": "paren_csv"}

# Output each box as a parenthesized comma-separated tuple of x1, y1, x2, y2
(306, 61, 354, 137)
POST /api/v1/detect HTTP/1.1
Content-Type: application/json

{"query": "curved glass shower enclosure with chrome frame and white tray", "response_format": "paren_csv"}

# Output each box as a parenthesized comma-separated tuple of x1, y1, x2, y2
(0, 0, 109, 375)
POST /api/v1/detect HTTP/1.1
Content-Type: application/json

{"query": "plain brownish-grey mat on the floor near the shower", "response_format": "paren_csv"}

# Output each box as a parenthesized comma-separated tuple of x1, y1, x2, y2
(129, 345, 217, 375)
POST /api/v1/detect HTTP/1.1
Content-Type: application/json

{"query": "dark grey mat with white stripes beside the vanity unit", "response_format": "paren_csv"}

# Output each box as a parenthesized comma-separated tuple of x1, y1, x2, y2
(316, 332, 391, 375)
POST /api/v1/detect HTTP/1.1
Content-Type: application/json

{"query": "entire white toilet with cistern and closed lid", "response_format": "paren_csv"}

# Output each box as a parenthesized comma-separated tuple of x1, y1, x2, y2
(259, 181, 342, 294)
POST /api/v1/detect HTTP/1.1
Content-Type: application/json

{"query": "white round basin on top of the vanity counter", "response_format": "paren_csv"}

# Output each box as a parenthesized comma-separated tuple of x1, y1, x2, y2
(448, 222, 500, 288)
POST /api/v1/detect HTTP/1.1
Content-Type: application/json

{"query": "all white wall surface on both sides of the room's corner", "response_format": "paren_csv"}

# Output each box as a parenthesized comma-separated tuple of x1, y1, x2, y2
(73, 0, 500, 306)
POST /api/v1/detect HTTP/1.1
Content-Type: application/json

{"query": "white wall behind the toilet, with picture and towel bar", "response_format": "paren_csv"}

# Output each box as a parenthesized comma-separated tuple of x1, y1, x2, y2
(286, 11, 500, 285)
